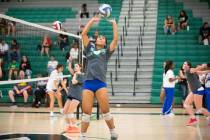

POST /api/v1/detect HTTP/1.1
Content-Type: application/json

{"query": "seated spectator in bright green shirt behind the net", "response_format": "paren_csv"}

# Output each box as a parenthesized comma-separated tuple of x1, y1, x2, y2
(8, 59, 19, 80)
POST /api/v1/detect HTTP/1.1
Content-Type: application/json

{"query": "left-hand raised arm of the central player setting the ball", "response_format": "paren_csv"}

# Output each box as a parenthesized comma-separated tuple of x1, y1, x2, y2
(81, 16, 100, 47)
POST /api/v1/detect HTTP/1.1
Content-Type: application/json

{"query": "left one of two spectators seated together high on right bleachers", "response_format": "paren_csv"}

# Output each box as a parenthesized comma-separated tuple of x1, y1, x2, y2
(164, 16, 176, 35)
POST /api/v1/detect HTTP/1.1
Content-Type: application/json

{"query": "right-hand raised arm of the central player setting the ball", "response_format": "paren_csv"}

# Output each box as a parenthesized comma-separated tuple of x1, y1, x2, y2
(109, 20, 118, 52)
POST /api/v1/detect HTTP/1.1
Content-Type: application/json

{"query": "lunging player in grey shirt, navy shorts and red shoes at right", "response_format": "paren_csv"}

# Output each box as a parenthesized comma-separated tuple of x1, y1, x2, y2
(183, 62, 210, 126)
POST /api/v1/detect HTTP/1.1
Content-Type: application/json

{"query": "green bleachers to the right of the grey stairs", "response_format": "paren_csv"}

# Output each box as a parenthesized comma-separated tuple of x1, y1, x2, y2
(151, 0, 210, 103)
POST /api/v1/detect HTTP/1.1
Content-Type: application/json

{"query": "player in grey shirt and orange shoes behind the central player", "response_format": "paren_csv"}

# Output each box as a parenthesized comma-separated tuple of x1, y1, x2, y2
(63, 62, 84, 133)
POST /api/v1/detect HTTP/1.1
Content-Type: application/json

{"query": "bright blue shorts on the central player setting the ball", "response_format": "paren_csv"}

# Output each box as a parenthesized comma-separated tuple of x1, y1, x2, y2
(83, 79, 107, 93)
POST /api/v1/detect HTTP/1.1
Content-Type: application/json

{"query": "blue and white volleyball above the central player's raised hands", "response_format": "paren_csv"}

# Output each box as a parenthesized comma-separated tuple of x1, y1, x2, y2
(98, 4, 112, 18)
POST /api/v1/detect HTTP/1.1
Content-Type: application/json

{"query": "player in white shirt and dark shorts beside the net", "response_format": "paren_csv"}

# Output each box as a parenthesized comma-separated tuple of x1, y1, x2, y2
(46, 64, 67, 117)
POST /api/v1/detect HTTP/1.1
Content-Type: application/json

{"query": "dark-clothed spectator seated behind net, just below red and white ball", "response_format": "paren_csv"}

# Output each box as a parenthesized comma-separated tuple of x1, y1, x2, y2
(58, 29, 69, 51)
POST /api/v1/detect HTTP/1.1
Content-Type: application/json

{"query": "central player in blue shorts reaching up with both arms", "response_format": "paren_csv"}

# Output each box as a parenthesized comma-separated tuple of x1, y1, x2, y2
(81, 16, 118, 140)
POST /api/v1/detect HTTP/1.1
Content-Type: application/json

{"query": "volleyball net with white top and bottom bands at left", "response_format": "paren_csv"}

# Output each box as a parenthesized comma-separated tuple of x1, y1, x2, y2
(0, 14, 83, 92)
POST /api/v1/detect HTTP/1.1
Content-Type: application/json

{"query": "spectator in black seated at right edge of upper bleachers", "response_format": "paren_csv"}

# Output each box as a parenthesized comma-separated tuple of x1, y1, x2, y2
(199, 22, 210, 45)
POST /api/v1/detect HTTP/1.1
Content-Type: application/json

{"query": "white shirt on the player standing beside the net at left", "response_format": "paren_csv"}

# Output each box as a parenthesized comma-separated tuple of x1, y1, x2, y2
(47, 70, 63, 91)
